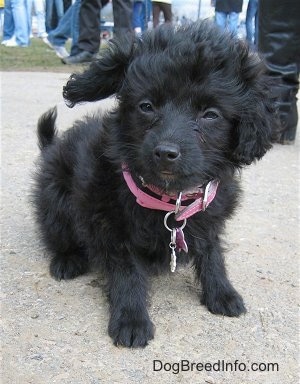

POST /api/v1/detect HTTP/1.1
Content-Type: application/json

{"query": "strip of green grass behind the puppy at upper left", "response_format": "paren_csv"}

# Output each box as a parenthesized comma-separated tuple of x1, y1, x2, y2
(0, 38, 94, 72)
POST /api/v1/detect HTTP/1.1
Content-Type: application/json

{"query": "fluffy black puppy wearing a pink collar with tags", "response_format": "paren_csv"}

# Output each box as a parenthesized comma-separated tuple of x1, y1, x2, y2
(34, 22, 275, 347)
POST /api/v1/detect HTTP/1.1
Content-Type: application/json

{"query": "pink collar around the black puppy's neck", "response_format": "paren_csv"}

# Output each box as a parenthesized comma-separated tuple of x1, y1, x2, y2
(123, 166, 219, 221)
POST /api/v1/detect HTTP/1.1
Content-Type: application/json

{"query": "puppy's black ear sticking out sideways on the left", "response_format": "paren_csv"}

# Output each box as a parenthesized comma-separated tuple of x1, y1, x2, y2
(63, 35, 135, 107)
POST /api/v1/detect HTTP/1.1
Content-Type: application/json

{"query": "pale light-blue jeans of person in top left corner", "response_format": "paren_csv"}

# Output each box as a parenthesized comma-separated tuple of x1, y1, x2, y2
(3, 0, 29, 47)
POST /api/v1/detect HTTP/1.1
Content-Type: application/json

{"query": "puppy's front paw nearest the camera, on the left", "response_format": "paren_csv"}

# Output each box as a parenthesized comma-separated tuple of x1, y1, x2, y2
(108, 318, 154, 348)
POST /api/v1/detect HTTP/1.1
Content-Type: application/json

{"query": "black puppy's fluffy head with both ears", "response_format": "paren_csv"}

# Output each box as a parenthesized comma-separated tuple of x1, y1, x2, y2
(63, 22, 276, 190)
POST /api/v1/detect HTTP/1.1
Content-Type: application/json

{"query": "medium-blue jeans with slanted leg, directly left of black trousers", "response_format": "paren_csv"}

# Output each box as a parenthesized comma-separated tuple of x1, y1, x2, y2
(48, 0, 80, 56)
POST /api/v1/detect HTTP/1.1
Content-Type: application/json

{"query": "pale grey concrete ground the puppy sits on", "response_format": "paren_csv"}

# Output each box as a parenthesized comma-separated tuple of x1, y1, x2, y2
(1, 72, 299, 384)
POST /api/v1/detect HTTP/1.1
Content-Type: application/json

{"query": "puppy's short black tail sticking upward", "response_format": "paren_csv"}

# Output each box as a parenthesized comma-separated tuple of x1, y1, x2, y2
(37, 107, 57, 150)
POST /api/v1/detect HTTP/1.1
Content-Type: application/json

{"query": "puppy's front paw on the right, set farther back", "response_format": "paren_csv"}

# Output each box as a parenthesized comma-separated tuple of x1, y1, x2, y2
(201, 288, 246, 317)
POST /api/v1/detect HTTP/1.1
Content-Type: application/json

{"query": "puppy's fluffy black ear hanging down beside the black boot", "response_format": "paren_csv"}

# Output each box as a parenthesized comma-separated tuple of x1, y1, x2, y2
(233, 53, 278, 166)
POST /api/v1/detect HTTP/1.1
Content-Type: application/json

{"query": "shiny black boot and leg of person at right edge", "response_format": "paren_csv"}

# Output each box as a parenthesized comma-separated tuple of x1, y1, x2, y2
(258, 0, 300, 144)
